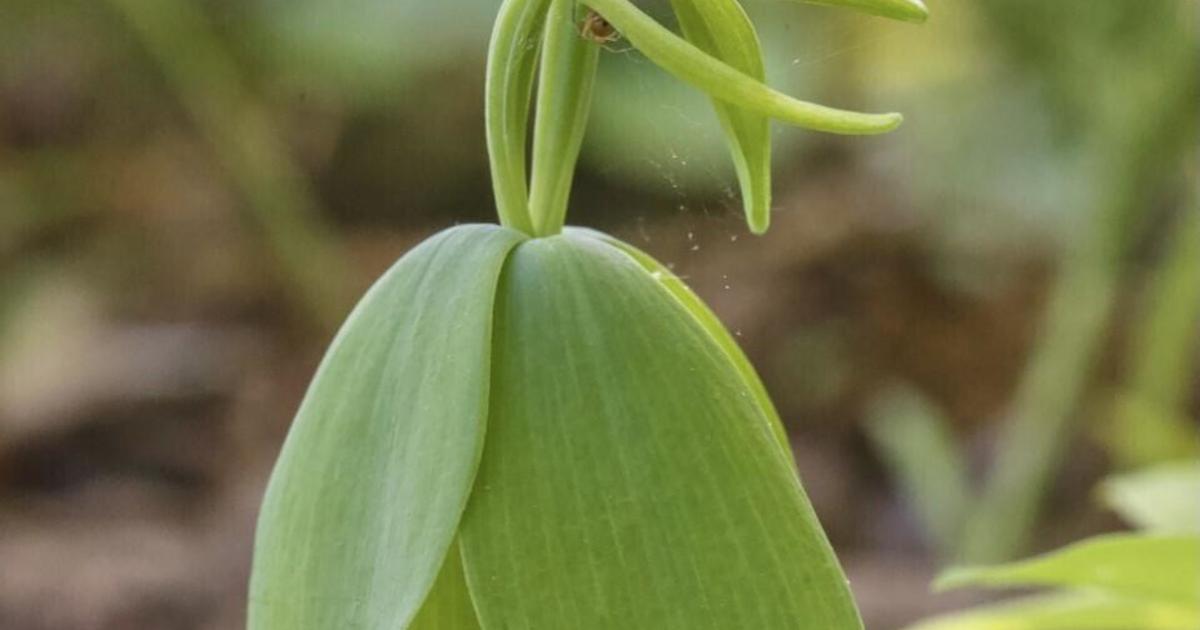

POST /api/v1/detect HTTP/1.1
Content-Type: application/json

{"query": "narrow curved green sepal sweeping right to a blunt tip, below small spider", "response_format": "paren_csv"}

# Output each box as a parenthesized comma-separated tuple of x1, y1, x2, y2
(584, 0, 904, 134)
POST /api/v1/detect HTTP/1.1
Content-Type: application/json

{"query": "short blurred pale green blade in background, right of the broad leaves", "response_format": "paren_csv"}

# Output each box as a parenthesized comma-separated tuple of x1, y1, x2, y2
(865, 386, 971, 557)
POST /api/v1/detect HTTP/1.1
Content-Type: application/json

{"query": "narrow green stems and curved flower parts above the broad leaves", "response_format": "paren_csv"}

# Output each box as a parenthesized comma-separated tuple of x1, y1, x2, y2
(487, 0, 926, 235)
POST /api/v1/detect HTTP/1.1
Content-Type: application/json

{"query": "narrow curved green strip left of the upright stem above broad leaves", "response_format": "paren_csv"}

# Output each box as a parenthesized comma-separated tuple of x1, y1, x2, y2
(485, 0, 550, 234)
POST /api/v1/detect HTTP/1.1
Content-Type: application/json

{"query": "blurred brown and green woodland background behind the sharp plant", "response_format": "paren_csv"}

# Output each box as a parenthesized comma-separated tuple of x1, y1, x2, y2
(0, 0, 1200, 630)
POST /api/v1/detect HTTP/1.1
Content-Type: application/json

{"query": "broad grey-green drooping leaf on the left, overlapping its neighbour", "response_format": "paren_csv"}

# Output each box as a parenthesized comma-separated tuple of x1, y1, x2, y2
(248, 226, 522, 630)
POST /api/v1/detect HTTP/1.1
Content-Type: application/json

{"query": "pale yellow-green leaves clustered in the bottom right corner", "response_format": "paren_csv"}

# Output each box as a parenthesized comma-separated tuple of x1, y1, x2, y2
(910, 463, 1200, 630)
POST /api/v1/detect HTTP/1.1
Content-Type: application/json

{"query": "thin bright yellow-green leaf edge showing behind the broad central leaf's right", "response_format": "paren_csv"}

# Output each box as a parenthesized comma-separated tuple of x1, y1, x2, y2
(568, 228, 794, 463)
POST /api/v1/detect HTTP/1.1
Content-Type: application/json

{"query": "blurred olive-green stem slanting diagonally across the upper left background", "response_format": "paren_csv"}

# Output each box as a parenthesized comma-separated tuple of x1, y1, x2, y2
(109, 0, 349, 330)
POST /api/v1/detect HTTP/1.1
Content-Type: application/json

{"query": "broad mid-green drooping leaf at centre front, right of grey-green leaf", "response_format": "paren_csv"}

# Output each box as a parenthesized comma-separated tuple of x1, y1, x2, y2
(461, 234, 860, 630)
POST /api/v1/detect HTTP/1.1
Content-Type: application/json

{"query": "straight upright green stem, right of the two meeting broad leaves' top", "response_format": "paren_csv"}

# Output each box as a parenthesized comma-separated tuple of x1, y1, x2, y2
(529, 0, 600, 236)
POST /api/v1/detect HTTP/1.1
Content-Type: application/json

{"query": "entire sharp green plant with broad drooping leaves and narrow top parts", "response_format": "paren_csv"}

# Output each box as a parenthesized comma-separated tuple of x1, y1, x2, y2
(243, 0, 924, 630)
